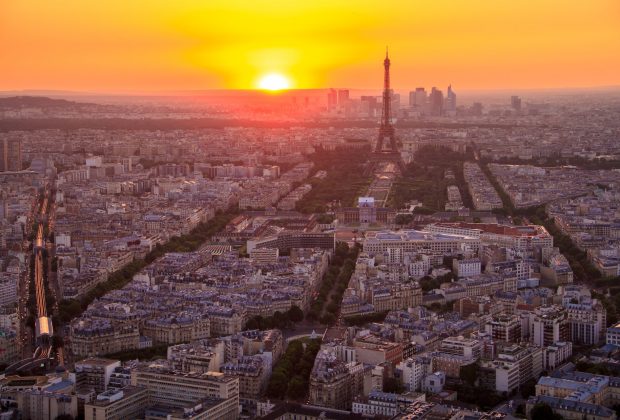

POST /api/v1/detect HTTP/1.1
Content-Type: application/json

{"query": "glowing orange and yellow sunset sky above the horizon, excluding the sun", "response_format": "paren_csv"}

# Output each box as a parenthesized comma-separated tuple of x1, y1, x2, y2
(0, 0, 620, 92)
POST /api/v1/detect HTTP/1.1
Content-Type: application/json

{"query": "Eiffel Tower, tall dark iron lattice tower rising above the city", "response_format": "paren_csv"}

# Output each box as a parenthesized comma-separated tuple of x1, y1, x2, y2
(370, 48, 405, 173)
